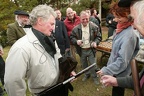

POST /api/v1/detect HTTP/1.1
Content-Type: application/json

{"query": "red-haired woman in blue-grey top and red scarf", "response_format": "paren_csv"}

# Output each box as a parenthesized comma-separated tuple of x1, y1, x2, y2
(97, 2, 139, 96)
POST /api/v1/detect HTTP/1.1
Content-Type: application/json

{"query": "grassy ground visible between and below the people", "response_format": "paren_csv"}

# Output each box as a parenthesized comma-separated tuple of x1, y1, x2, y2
(3, 27, 133, 96)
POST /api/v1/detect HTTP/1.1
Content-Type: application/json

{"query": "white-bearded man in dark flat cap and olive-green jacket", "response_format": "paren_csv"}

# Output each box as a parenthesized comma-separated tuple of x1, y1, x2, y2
(7, 10, 31, 45)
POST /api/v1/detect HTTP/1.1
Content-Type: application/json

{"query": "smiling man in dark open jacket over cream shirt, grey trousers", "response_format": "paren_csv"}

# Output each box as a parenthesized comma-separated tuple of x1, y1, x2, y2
(70, 11, 102, 84)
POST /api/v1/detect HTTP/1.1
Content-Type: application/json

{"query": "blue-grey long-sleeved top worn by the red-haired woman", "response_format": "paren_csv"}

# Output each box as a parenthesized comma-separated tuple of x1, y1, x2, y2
(102, 26, 139, 77)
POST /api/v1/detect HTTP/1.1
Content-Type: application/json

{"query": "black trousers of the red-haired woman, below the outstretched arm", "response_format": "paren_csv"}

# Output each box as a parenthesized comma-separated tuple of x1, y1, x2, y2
(112, 87, 125, 96)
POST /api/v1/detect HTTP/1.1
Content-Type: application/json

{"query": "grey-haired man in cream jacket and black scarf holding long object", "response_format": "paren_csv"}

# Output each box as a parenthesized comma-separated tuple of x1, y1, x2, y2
(4, 5, 75, 96)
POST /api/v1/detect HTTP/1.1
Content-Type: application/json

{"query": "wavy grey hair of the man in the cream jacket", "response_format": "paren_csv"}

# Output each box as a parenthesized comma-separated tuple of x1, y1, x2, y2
(29, 5, 57, 25)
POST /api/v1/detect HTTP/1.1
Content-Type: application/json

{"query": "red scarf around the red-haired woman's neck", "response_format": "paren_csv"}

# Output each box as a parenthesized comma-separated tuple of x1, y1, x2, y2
(116, 22, 133, 34)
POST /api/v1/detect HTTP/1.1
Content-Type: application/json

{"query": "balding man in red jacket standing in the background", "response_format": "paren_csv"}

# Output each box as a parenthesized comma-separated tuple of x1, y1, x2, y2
(64, 8, 80, 59)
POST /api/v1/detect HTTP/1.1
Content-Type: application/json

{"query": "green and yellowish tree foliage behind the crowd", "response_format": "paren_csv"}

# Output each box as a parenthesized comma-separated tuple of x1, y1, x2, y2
(0, 0, 119, 47)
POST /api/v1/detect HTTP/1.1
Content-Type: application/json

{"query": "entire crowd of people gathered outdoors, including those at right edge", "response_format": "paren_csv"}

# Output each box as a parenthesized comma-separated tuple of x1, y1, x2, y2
(0, 0, 144, 96)
